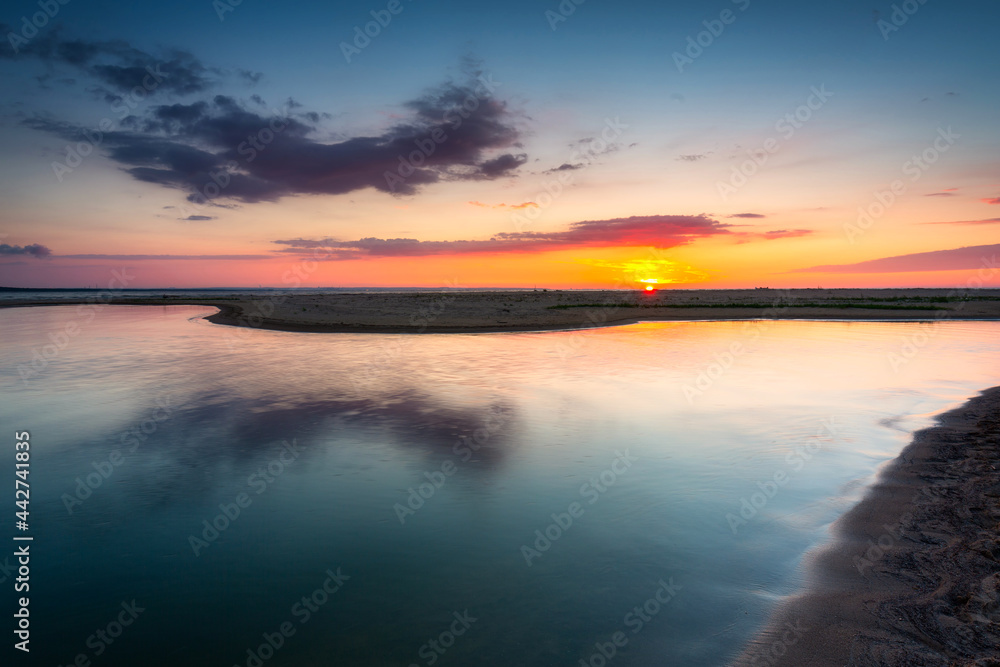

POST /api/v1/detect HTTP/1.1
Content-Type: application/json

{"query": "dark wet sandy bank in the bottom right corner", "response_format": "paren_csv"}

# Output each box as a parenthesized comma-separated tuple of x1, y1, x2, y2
(731, 387, 1000, 667)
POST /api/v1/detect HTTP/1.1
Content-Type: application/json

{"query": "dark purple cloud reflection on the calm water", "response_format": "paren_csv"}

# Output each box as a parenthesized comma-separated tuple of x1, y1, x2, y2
(58, 389, 516, 508)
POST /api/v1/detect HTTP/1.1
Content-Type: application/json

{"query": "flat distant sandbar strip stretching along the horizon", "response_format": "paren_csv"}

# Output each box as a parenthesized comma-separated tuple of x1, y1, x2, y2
(0, 289, 1000, 333)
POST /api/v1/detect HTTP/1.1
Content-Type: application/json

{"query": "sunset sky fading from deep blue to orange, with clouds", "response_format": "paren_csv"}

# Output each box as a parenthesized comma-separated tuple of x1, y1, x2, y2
(0, 0, 1000, 289)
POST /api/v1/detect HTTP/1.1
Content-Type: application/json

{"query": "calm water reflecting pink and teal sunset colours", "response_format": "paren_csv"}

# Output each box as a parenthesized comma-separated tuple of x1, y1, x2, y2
(0, 306, 1000, 667)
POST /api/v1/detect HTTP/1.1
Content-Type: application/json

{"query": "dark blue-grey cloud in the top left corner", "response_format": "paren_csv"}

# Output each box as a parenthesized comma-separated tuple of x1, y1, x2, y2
(0, 23, 215, 96)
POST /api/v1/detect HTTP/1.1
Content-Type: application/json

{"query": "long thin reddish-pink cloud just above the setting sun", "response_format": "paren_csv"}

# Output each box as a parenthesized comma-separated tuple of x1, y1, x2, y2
(274, 215, 730, 260)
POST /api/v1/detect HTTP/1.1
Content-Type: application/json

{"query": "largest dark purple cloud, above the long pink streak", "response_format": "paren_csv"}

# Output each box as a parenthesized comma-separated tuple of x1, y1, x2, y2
(25, 77, 527, 204)
